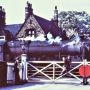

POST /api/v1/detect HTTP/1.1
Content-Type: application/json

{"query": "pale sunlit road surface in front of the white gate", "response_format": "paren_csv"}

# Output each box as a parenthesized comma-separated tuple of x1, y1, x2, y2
(0, 80, 90, 90)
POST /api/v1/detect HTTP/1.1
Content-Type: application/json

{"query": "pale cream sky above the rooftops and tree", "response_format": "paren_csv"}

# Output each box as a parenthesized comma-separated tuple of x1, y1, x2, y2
(0, 0, 90, 24)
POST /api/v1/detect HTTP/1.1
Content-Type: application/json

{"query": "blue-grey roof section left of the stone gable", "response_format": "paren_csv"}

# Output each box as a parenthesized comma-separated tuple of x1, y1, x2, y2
(5, 24, 22, 36)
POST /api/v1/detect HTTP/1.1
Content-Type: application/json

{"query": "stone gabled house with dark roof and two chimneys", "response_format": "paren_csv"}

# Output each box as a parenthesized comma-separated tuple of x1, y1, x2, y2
(5, 2, 62, 40)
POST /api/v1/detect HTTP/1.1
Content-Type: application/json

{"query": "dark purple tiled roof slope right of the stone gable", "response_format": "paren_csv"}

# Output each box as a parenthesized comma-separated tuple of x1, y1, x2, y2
(34, 15, 61, 37)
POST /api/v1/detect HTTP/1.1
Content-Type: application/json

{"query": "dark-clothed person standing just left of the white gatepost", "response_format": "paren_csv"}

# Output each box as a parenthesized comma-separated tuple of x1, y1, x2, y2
(14, 60, 20, 84)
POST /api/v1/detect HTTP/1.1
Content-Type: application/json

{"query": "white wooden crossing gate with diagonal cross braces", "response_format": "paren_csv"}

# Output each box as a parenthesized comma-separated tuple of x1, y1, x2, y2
(27, 61, 90, 82)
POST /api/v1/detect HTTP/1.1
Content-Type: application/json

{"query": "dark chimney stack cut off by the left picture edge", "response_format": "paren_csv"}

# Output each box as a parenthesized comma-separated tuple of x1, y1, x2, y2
(0, 6, 6, 29)
